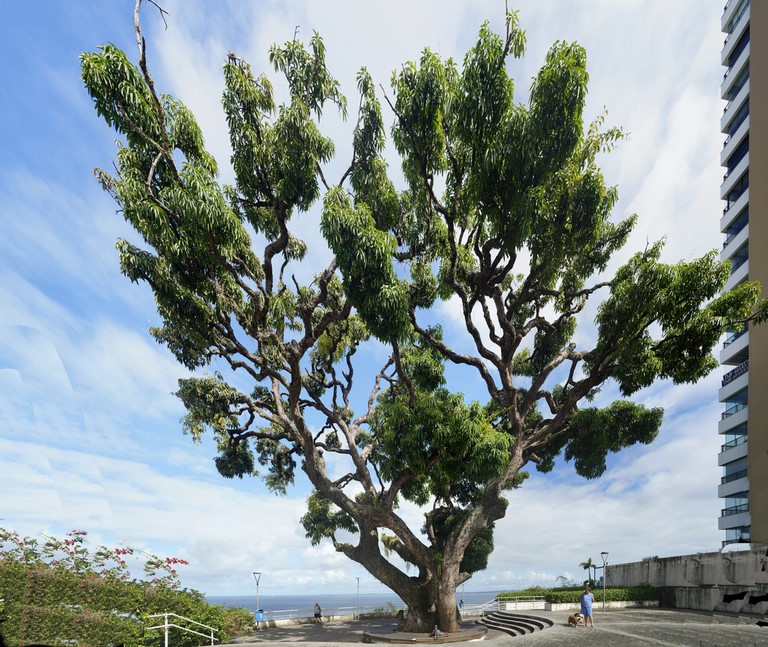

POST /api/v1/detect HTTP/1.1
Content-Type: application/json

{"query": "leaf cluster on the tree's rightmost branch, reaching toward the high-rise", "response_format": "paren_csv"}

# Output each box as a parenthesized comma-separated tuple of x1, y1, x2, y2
(587, 243, 757, 395)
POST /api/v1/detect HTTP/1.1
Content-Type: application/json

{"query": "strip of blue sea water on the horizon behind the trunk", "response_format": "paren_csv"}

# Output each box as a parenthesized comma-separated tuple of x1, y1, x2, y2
(205, 589, 508, 616)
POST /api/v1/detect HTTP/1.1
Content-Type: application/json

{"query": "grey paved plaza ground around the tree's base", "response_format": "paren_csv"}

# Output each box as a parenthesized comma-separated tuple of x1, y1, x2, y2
(230, 609, 768, 647)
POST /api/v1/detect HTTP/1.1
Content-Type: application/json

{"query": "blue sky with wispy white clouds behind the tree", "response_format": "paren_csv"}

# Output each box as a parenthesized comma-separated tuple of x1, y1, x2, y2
(0, 0, 723, 594)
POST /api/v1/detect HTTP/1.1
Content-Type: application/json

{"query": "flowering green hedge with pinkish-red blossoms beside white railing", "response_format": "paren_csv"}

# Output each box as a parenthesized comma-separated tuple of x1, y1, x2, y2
(0, 529, 232, 647)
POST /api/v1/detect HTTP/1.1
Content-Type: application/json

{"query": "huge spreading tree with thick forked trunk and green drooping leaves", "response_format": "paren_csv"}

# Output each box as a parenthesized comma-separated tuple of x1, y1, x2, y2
(82, 0, 758, 631)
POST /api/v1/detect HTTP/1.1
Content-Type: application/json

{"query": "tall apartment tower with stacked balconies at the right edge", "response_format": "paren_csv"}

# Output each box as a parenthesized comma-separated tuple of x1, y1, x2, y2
(718, 0, 768, 545)
